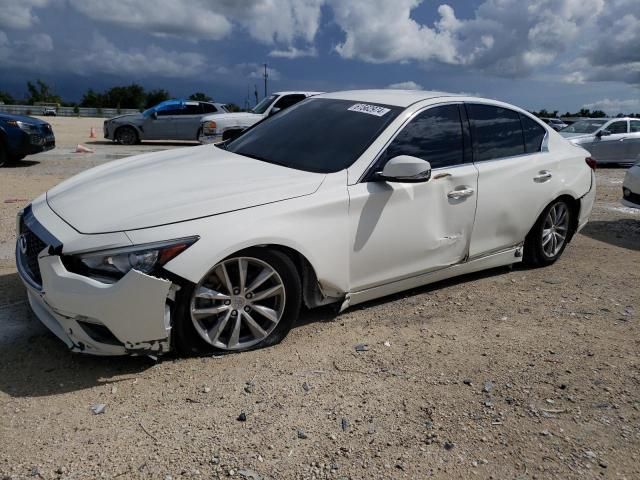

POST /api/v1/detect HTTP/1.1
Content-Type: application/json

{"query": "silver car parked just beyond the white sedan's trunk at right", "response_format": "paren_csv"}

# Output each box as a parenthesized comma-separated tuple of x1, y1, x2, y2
(560, 118, 640, 164)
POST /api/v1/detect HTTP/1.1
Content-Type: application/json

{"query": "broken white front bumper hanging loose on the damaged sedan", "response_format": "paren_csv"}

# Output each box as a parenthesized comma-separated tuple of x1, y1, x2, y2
(16, 204, 176, 355)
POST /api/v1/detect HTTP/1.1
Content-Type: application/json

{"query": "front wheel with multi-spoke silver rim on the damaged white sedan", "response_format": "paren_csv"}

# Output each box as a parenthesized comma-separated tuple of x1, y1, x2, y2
(173, 248, 302, 355)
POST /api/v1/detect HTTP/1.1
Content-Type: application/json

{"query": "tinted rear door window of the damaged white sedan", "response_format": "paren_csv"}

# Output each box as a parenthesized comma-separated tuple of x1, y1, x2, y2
(467, 103, 525, 162)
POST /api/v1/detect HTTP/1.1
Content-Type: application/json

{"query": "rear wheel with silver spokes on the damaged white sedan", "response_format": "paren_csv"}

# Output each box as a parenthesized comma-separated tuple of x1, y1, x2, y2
(523, 199, 573, 267)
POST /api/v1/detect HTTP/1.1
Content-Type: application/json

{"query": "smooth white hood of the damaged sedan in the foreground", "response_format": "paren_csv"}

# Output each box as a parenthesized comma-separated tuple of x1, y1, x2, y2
(47, 145, 325, 234)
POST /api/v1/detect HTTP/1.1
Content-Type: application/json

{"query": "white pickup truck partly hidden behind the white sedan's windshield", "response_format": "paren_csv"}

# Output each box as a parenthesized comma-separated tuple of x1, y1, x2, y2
(199, 92, 322, 143)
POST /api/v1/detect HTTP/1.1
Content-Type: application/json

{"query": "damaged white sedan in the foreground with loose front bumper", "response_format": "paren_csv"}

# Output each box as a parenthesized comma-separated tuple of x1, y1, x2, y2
(16, 90, 595, 355)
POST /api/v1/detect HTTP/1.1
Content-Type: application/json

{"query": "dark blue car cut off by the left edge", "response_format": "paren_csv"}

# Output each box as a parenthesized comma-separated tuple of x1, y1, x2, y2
(0, 113, 56, 167)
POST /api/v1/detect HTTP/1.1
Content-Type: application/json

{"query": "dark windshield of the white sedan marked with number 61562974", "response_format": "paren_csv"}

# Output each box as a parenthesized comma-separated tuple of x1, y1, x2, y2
(227, 98, 403, 173)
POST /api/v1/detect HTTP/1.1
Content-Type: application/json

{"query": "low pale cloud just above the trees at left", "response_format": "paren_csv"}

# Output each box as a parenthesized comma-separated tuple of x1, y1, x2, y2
(69, 34, 207, 78)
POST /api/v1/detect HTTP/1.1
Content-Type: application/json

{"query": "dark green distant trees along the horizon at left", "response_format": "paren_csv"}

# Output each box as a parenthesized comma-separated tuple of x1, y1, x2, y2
(0, 79, 239, 111)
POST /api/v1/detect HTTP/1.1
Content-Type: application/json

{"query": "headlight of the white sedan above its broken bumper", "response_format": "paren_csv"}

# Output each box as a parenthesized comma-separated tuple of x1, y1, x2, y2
(71, 237, 199, 277)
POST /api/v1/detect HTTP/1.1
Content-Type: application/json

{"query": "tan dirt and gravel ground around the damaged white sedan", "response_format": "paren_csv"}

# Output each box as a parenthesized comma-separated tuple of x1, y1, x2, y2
(0, 118, 640, 480)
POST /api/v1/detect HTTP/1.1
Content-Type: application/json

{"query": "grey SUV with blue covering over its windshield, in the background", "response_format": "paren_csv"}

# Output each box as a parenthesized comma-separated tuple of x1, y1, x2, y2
(104, 100, 228, 145)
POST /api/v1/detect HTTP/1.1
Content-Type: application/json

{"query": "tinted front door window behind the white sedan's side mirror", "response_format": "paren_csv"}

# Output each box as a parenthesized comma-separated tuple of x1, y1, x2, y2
(377, 105, 464, 168)
